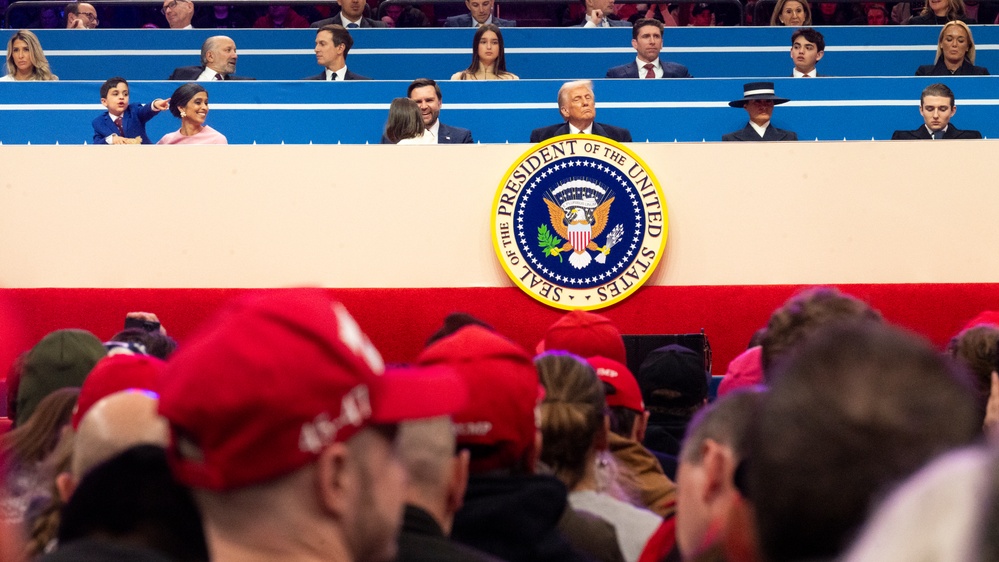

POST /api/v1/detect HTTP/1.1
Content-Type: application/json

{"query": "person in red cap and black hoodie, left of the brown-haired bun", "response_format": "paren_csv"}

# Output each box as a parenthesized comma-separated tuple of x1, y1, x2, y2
(418, 325, 596, 562)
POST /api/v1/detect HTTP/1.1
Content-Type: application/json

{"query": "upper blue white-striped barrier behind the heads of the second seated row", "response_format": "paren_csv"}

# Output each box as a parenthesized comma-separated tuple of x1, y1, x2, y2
(19, 26, 999, 80)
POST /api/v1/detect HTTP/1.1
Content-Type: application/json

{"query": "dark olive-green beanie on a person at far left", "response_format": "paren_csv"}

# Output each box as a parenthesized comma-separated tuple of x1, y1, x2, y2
(17, 330, 107, 425)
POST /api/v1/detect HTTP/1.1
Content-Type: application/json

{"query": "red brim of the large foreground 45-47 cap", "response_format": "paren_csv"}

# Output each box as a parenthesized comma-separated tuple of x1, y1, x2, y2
(371, 365, 468, 423)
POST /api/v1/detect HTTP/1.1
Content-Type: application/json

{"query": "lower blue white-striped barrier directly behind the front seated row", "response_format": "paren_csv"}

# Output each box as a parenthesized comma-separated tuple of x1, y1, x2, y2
(0, 77, 999, 144)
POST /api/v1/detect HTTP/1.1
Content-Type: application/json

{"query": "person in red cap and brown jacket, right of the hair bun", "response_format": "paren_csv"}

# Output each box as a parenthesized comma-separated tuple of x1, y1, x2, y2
(587, 357, 676, 517)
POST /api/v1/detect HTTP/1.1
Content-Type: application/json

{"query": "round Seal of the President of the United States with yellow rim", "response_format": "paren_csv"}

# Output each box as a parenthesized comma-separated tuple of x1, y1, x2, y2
(492, 135, 668, 310)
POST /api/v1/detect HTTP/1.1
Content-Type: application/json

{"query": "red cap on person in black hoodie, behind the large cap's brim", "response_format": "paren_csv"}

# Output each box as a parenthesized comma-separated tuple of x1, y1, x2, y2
(417, 325, 543, 473)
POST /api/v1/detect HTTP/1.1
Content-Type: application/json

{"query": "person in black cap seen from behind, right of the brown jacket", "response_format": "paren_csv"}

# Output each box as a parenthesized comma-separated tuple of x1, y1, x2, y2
(635, 344, 708, 457)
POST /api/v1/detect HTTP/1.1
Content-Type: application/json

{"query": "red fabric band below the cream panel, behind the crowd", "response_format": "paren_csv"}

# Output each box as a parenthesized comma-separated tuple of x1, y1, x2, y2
(0, 283, 999, 374)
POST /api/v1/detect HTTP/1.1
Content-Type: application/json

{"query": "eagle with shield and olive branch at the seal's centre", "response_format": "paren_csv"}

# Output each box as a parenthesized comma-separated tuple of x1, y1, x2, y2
(538, 179, 624, 269)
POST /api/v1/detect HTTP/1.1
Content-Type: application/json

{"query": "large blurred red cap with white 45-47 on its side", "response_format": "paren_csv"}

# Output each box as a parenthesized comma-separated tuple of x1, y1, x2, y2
(159, 289, 468, 490)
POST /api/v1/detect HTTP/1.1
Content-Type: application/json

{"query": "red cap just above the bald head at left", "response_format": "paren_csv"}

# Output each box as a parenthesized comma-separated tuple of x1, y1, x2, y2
(70, 354, 166, 429)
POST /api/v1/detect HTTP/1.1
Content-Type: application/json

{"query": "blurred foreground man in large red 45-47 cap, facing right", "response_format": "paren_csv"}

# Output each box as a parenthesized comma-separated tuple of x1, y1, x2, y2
(160, 289, 467, 562)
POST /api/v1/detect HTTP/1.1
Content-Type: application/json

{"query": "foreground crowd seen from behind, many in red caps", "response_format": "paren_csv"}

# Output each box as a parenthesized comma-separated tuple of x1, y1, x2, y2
(0, 286, 999, 562)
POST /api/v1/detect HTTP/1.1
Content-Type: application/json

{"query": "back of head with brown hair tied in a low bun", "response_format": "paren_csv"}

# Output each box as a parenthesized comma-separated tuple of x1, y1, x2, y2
(534, 352, 606, 490)
